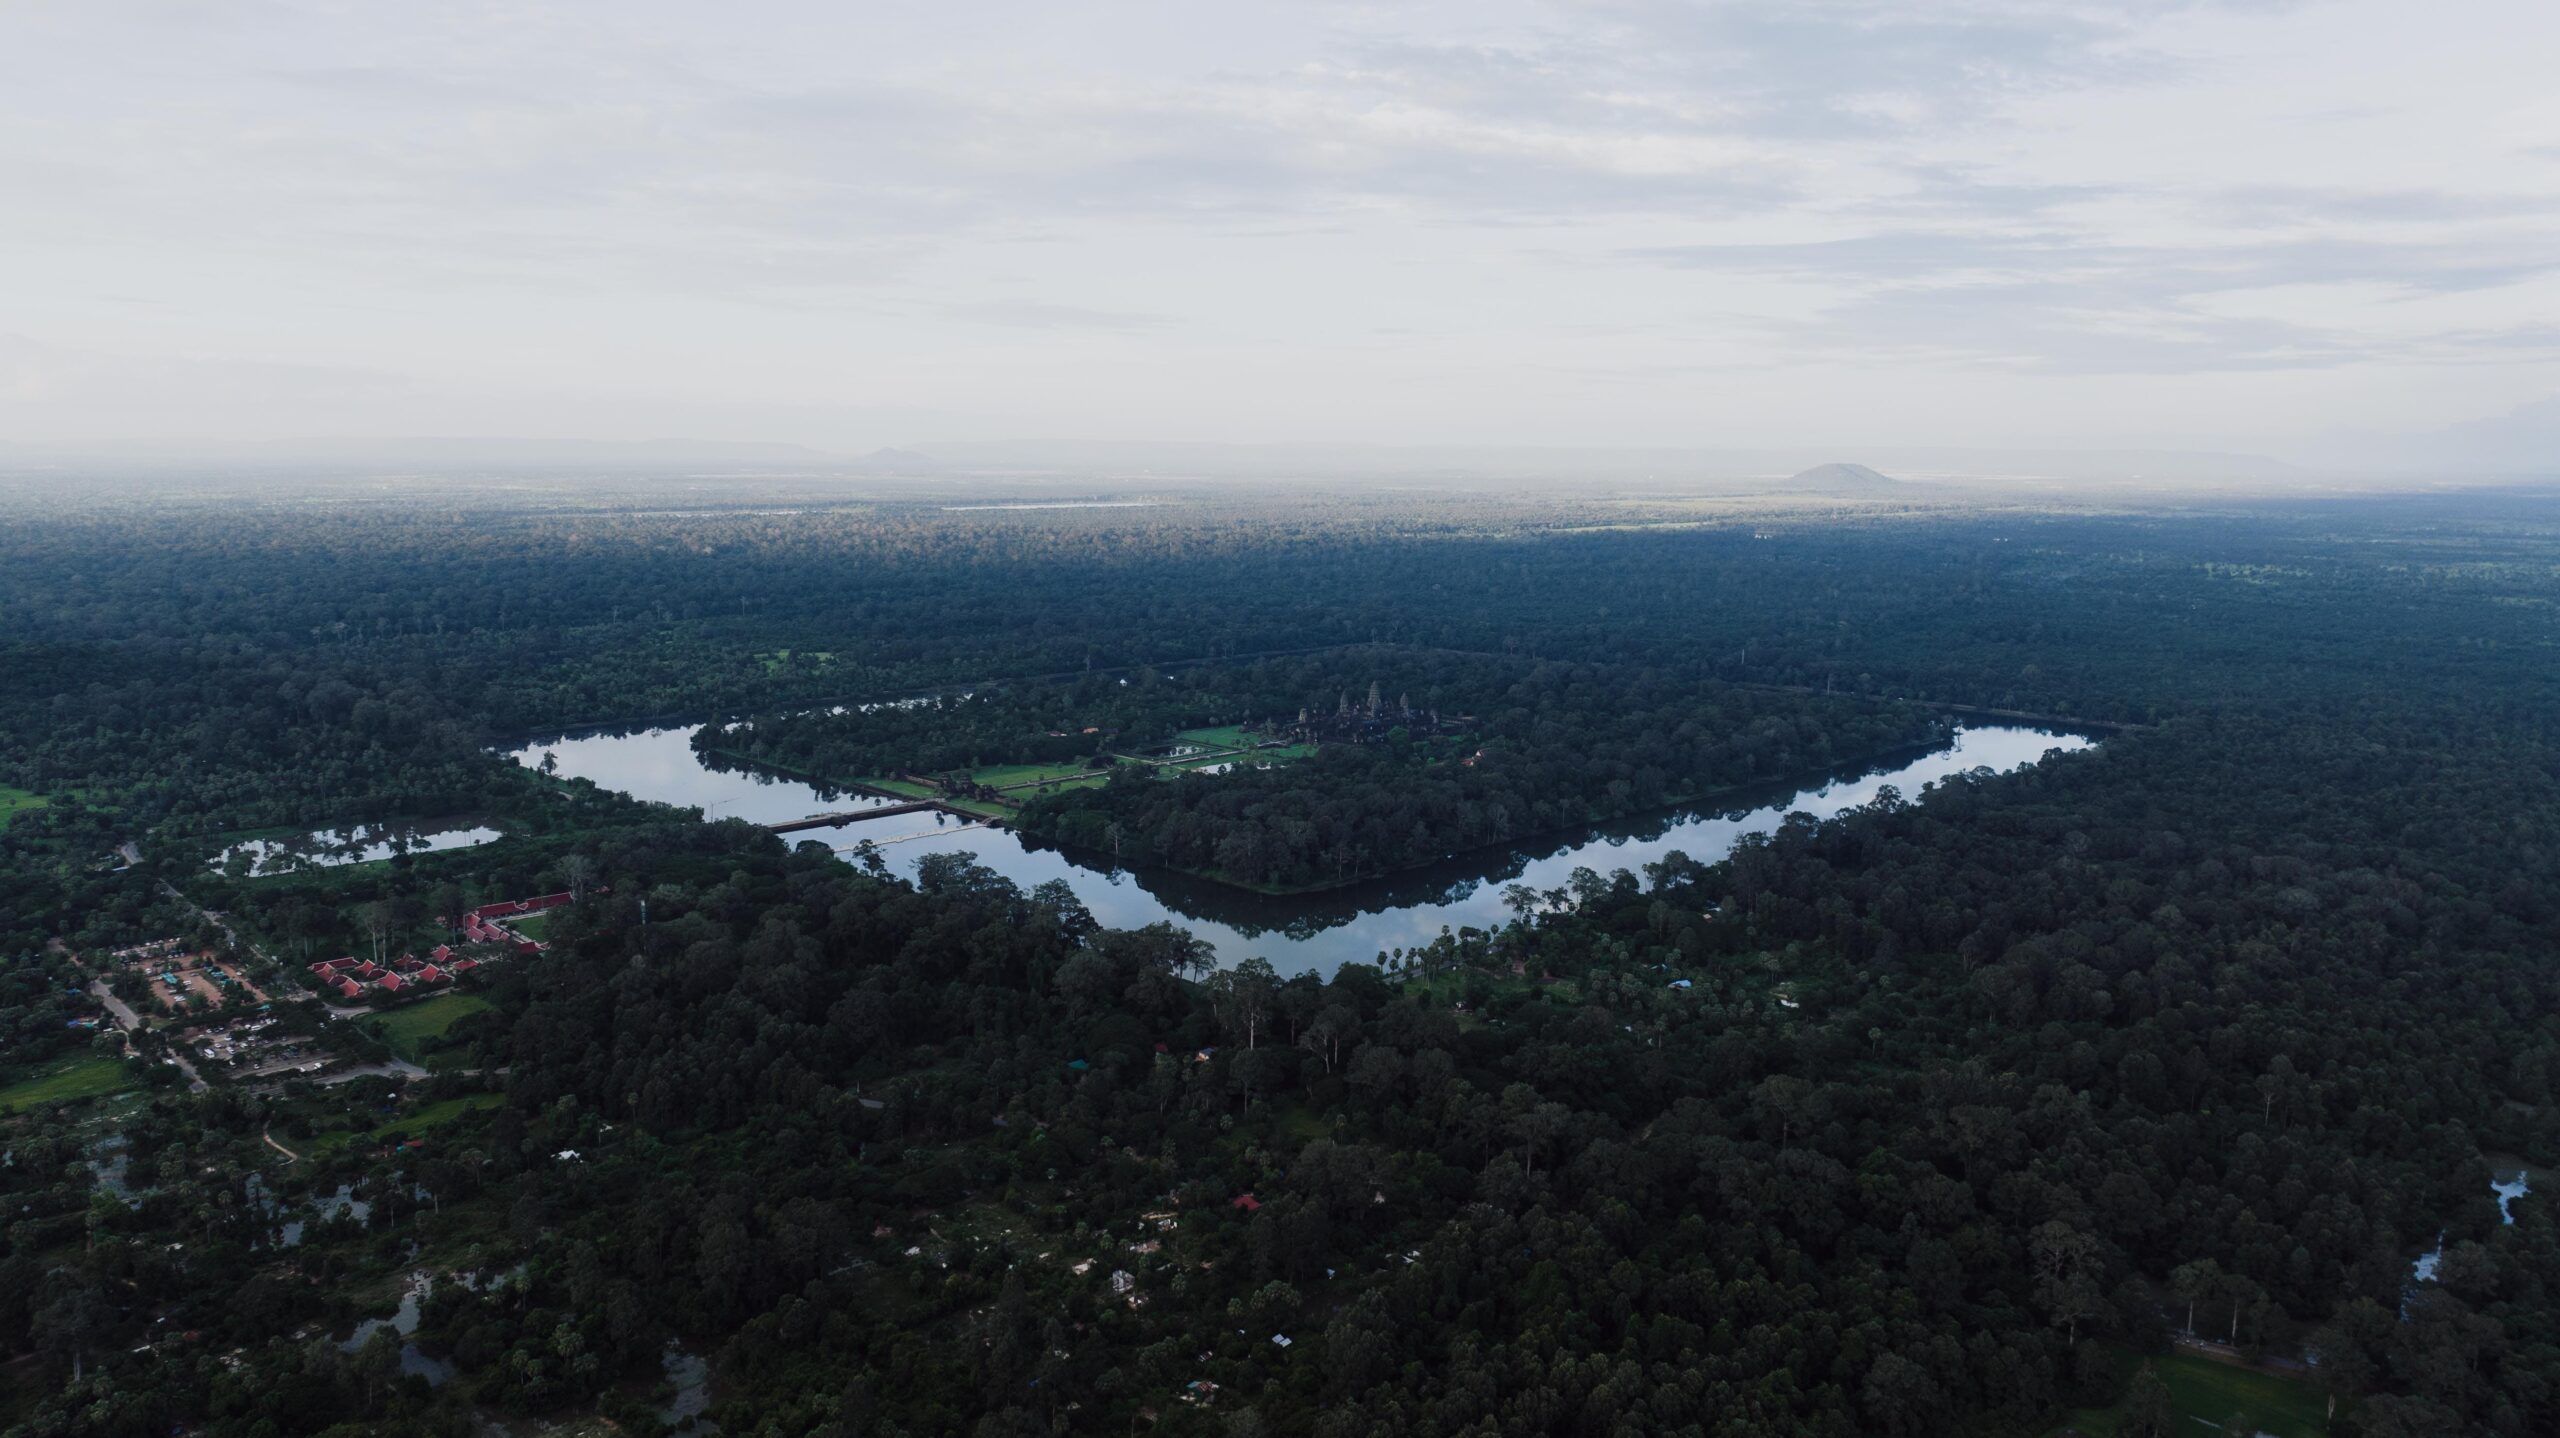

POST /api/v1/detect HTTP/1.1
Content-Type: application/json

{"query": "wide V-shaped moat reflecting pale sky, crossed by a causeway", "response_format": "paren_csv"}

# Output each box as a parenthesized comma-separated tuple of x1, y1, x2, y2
(512, 724, 2092, 972)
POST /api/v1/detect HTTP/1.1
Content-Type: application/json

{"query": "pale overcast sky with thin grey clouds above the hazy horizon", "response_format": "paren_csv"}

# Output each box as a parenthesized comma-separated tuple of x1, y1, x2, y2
(0, 0, 2560, 455)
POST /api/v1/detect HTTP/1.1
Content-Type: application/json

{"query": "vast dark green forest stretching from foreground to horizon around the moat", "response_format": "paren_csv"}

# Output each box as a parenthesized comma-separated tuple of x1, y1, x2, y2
(0, 481, 2560, 1438)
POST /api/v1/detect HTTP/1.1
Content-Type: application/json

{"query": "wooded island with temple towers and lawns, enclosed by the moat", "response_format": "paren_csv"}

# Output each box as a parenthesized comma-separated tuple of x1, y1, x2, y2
(694, 645, 1948, 888)
